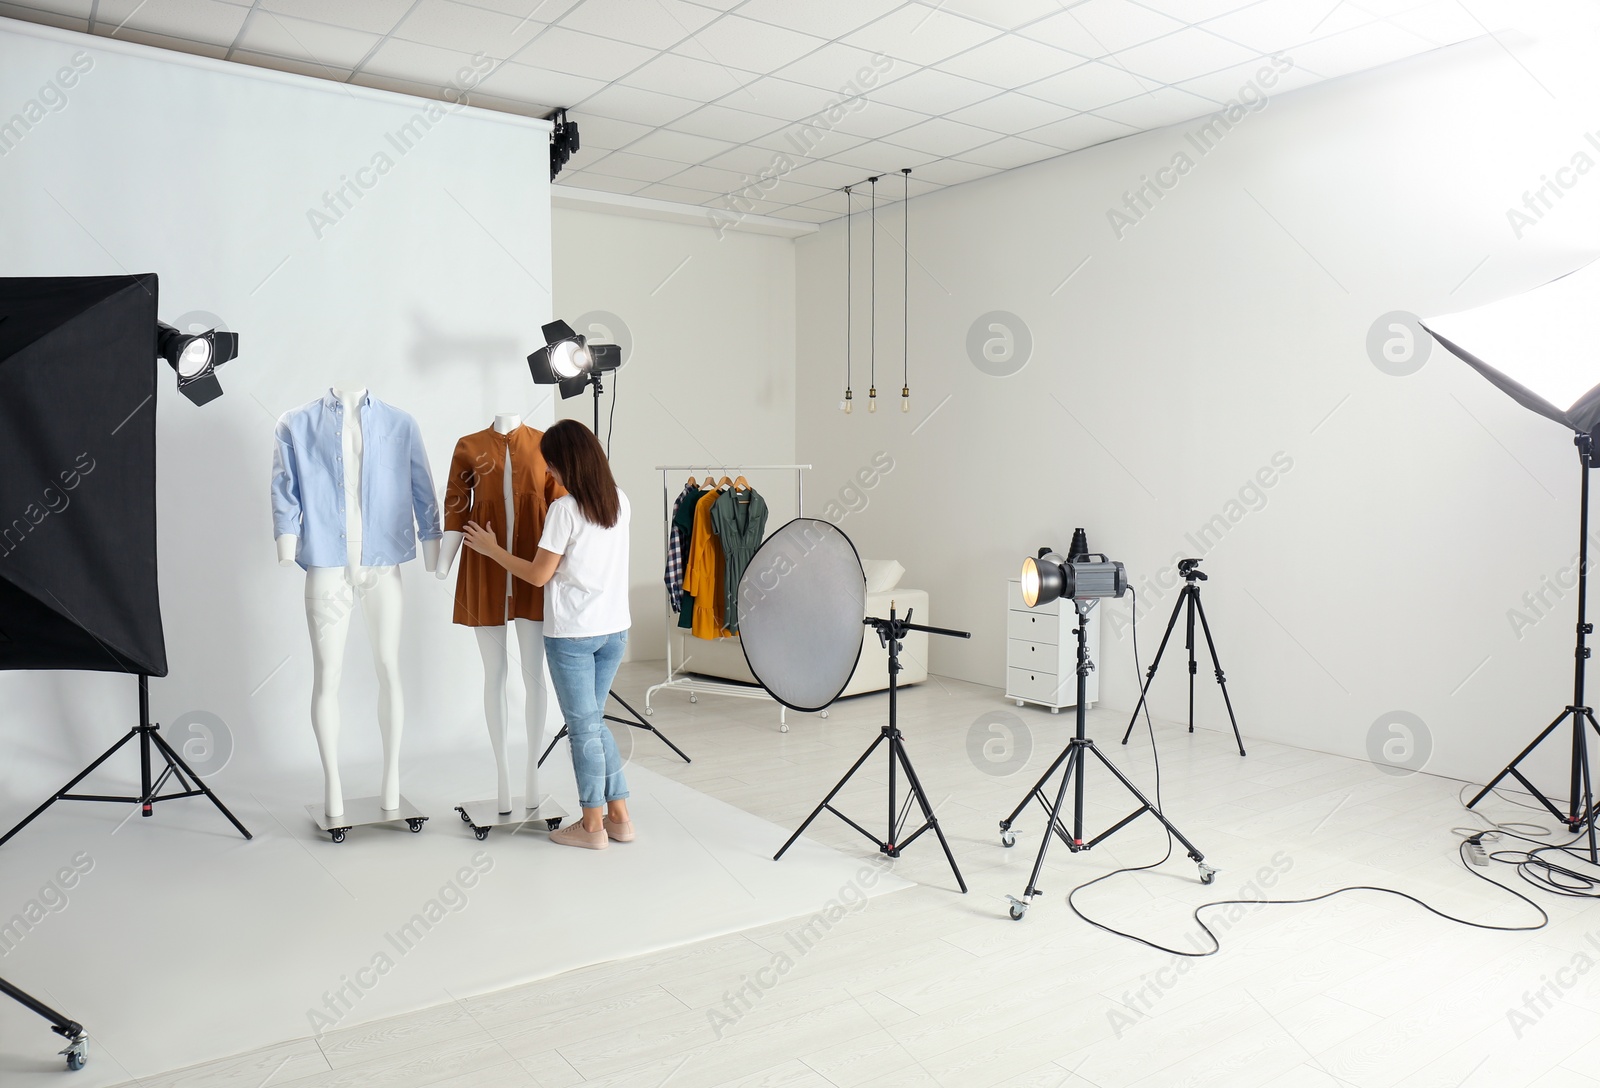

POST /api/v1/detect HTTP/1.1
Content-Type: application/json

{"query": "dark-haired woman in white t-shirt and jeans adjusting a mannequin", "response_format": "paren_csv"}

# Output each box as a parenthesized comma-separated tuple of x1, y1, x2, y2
(464, 419, 634, 850)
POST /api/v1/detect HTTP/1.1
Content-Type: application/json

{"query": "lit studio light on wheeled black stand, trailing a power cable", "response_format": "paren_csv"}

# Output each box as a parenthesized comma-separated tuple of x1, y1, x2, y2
(1000, 536, 1216, 922)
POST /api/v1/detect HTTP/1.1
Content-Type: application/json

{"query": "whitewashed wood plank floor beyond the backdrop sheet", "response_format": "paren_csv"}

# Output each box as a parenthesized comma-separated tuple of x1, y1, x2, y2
(103, 662, 1600, 1088)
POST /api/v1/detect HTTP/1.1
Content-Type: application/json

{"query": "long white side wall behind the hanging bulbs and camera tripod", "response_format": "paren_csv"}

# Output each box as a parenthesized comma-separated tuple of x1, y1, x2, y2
(797, 12, 1600, 784)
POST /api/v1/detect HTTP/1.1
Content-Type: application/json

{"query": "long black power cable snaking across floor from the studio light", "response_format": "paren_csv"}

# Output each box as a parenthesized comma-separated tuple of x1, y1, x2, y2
(1067, 586, 1555, 960)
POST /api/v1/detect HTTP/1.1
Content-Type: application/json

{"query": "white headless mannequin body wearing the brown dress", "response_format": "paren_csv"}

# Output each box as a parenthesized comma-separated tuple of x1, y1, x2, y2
(435, 413, 549, 816)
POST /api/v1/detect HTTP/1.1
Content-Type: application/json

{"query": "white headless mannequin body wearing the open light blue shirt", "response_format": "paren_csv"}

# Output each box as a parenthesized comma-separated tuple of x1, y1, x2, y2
(275, 379, 440, 821)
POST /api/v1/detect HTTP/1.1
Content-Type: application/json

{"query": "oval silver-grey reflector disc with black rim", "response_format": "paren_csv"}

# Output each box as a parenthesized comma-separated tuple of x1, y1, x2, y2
(739, 517, 867, 710)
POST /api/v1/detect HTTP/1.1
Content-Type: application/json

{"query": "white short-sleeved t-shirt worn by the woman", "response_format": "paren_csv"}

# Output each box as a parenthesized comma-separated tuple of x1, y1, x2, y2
(539, 488, 632, 638)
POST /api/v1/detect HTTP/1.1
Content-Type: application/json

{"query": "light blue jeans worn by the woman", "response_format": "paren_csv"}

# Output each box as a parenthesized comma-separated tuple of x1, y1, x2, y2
(544, 630, 627, 808)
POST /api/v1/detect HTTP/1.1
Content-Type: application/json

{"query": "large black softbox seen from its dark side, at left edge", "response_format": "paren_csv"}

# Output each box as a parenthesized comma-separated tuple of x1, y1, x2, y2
(0, 274, 166, 677)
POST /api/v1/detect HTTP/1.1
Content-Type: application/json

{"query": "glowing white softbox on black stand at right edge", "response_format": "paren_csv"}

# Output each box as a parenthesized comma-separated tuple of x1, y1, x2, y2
(1422, 262, 1600, 864)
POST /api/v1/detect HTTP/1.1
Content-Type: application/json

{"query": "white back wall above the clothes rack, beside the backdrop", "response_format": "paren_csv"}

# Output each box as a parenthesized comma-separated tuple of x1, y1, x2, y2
(554, 208, 795, 661)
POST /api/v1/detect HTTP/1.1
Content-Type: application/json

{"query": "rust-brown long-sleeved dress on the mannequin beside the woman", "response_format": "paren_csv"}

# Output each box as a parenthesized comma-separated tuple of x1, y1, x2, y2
(445, 426, 566, 627)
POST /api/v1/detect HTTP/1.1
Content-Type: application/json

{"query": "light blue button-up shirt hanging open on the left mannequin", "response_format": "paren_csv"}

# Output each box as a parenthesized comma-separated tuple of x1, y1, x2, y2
(272, 390, 443, 568)
